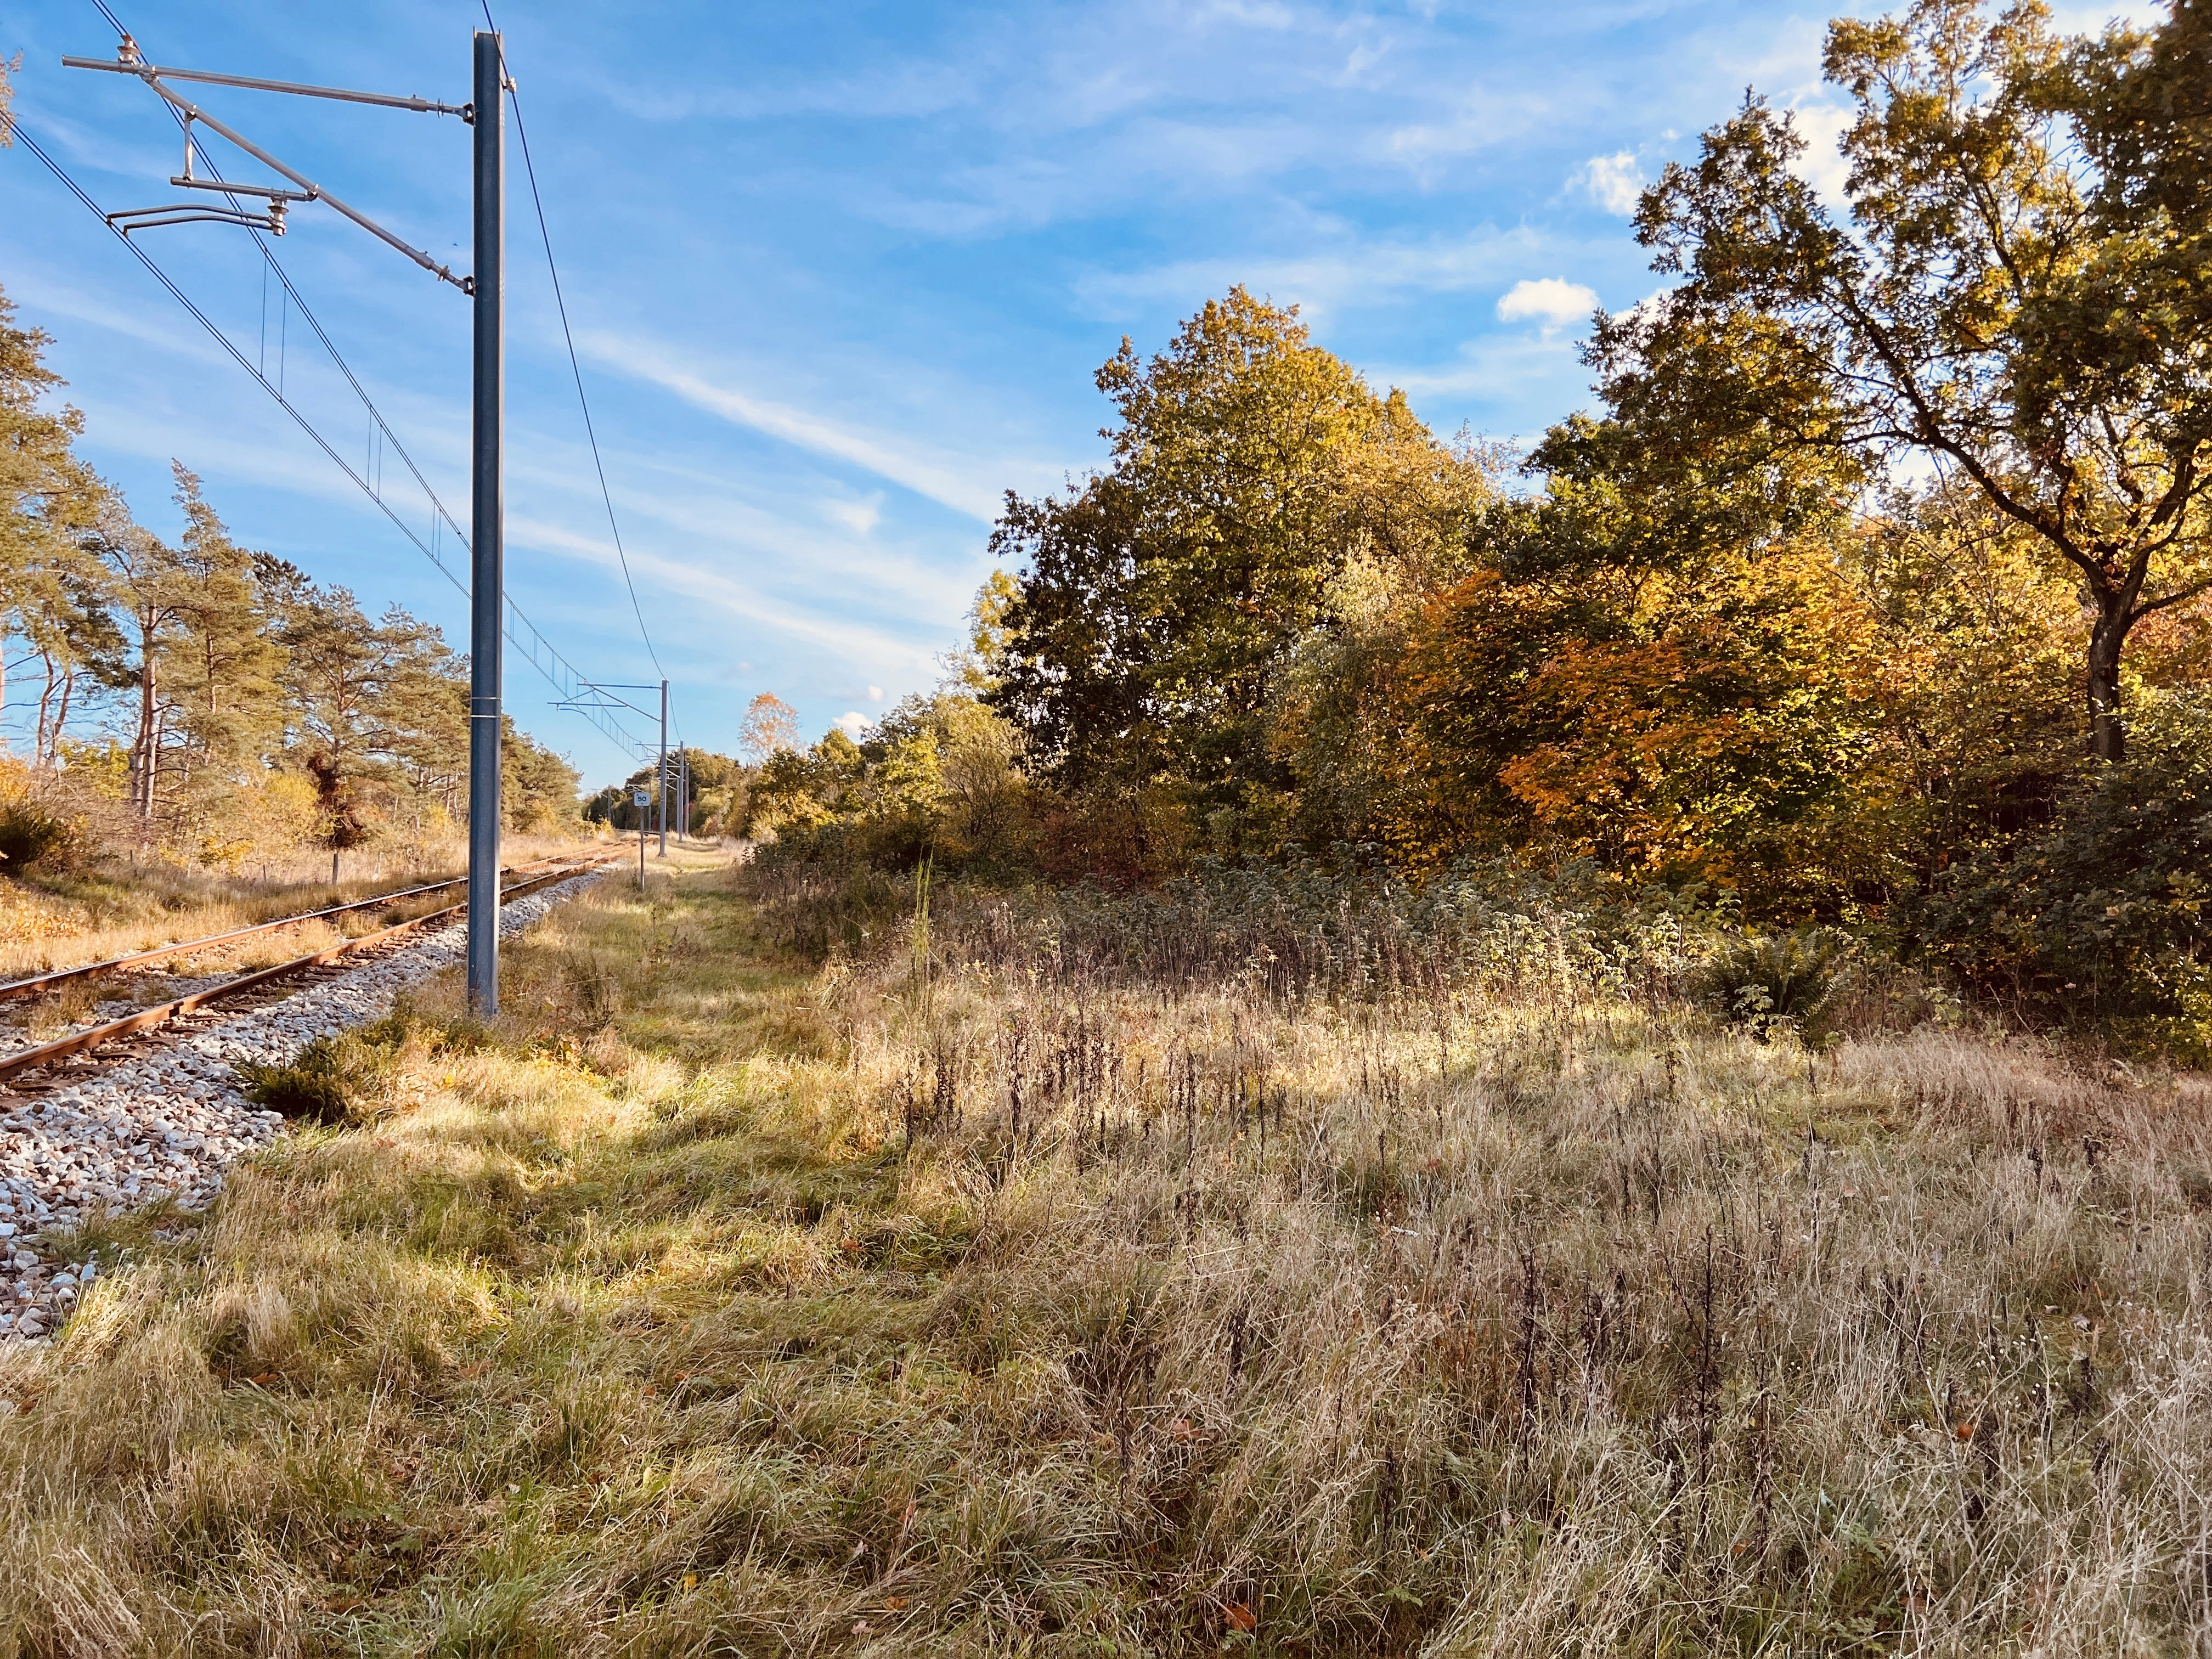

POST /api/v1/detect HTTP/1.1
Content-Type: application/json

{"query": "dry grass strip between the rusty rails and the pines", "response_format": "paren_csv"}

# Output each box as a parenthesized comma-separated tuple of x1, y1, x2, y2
(0, 836, 606, 980)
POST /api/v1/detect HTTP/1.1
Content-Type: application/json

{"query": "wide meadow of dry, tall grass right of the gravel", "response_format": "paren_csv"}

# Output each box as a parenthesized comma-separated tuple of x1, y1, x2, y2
(0, 867, 2212, 1655)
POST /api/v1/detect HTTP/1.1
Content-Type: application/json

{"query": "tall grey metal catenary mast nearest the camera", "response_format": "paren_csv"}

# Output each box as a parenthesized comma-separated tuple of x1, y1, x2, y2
(469, 31, 506, 1020)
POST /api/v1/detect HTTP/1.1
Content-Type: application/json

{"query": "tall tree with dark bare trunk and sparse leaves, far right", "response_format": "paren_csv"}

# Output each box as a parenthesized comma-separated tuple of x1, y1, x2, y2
(1619, 0, 2212, 761)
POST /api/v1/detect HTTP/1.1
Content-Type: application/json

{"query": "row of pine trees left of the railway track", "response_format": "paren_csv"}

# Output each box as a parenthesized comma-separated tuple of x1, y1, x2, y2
(0, 283, 577, 884)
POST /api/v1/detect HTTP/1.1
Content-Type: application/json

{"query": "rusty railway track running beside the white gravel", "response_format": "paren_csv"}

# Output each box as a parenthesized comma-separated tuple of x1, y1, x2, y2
(0, 849, 622, 1097)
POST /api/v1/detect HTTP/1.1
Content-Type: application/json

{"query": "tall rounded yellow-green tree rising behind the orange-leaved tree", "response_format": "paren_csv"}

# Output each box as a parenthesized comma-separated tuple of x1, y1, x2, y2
(989, 287, 1487, 845)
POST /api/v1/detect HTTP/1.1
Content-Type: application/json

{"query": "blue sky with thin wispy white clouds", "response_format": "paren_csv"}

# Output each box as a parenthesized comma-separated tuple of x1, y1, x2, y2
(0, 0, 2141, 783)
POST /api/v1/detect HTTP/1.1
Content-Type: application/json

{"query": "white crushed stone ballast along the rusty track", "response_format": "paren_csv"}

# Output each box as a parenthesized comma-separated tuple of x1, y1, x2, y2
(0, 872, 602, 1338)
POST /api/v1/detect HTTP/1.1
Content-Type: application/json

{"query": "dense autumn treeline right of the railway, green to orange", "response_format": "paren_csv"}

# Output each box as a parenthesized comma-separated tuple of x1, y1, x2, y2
(750, 0, 2212, 1046)
